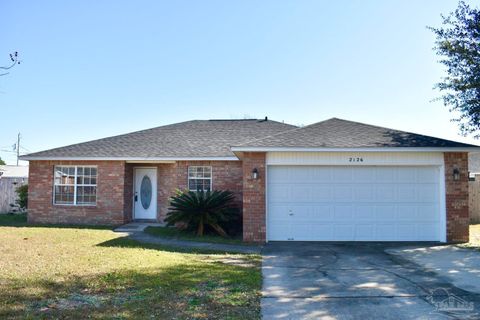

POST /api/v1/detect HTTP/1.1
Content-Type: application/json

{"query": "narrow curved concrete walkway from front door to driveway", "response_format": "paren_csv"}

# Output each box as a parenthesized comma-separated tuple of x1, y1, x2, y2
(114, 222, 262, 254)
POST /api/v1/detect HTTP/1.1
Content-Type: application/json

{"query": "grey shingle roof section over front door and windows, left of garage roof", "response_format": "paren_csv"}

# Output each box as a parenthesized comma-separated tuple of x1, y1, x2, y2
(22, 119, 296, 160)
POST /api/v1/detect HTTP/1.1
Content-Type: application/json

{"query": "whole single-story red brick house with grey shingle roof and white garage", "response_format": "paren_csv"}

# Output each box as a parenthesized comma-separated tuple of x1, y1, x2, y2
(22, 118, 480, 242)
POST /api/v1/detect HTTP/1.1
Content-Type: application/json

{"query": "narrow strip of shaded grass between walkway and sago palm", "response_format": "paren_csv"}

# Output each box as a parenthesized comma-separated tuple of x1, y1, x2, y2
(145, 227, 253, 245)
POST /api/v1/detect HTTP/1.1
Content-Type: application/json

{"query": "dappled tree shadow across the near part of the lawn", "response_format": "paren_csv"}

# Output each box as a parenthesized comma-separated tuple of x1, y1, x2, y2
(0, 261, 261, 319)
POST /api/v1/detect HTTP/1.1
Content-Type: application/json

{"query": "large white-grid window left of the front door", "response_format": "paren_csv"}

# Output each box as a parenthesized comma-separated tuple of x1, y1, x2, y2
(53, 166, 97, 205)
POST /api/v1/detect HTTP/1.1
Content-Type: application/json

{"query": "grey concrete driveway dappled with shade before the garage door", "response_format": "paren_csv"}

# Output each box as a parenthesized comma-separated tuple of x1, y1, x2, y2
(262, 242, 480, 319)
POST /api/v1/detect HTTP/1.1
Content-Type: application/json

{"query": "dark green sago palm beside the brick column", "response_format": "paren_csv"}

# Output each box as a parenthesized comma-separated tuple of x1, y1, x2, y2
(165, 190, 238, 237)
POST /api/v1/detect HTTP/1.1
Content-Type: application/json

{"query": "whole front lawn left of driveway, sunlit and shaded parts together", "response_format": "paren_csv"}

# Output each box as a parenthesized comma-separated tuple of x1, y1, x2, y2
(0, 215, 261, 319)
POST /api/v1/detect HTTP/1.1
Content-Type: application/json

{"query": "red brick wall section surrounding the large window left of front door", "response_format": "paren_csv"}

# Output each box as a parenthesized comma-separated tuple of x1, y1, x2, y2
(28, 161, 125, 225)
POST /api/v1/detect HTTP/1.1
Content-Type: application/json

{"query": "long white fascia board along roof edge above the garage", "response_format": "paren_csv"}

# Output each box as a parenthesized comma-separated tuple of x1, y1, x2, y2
(230, 146, 480, 152)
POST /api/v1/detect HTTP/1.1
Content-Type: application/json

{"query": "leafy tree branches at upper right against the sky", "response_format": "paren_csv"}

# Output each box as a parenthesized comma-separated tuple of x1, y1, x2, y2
(428, 1, 480, 138)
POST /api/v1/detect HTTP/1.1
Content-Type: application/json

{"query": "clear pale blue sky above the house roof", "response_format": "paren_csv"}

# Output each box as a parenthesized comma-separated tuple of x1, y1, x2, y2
(0, 0, 480, 164)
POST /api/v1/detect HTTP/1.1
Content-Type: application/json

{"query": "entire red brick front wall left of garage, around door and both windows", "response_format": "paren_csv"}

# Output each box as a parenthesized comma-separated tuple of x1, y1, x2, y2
(28, 161, 243, 225)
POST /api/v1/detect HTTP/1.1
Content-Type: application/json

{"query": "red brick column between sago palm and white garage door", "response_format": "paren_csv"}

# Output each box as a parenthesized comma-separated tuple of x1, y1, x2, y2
(242, 152, 266, 242)
